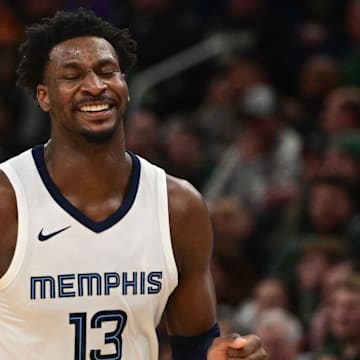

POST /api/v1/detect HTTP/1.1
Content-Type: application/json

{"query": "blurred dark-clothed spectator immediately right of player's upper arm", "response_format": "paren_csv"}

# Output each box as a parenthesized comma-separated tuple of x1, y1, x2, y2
(210, 198, 257, 306)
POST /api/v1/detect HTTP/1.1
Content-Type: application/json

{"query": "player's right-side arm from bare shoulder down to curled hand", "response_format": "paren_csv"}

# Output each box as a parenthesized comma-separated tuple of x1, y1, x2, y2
(165, 177, 266, 360)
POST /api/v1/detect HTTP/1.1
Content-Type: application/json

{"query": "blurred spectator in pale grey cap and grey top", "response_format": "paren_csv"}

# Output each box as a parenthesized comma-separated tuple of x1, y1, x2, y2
(204, 86, 301, 213)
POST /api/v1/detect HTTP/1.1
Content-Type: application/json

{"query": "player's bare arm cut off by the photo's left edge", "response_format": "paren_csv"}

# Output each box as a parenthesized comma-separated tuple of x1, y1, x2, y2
(0, 171, 17, 278)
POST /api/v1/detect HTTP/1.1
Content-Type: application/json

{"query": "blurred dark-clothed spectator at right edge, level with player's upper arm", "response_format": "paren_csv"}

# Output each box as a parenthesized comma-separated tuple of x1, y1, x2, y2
(270, 177, 359, 300)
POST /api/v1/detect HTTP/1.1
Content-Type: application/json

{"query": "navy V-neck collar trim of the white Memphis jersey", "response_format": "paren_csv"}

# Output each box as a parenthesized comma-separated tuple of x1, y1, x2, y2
(32, 145, 141, 233)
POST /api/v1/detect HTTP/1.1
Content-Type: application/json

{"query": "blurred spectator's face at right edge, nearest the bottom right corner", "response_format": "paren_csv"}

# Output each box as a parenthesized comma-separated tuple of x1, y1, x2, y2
(330, 288, 360, 341)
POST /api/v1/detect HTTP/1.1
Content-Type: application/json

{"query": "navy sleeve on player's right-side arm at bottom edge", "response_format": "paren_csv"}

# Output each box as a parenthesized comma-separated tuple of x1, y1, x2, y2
(169, 323, 220, 360)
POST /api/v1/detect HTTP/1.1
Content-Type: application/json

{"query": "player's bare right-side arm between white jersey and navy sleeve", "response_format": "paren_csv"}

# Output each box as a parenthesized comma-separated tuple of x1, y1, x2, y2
(165, 177, 216, 336)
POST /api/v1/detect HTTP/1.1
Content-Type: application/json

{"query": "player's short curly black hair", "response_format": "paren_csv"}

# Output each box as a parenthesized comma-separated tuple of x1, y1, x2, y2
(16, 8, 137, 97)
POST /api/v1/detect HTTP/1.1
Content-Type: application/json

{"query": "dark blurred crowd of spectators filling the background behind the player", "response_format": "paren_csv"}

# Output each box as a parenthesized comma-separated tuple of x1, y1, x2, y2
(0, 0, 360, 360)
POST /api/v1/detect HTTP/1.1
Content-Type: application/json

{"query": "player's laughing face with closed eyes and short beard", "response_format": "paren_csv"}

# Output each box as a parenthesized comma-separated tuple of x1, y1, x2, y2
(37, 36, 128, 143)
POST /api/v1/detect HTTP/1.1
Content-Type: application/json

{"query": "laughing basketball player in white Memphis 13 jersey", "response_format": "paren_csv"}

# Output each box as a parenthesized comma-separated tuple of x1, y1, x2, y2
(0, 10, 265, 360)
